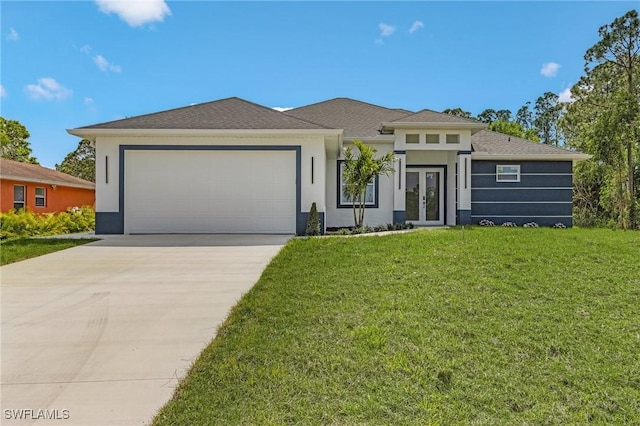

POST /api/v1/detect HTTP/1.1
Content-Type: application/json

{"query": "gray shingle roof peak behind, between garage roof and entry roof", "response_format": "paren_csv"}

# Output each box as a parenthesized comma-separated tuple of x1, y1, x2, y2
(285, 98, 412, 138)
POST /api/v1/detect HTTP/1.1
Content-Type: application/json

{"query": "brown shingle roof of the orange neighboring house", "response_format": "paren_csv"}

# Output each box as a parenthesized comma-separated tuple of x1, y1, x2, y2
(0, 158, 96, 189)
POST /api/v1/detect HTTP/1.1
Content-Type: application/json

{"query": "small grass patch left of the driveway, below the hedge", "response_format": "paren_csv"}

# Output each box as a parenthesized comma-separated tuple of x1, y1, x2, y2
(0, 238, 97, 265)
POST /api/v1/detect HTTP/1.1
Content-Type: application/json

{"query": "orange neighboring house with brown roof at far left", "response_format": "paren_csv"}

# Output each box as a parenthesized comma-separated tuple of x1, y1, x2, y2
(0, 158, 96, 213)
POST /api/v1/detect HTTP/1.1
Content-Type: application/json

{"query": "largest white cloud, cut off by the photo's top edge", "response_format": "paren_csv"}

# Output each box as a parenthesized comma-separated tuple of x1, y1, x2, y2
(95, 0, 171, 27)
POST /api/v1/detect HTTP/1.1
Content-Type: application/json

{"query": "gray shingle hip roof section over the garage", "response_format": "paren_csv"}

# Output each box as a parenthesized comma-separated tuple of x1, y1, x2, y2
(80, 98, 324, 130)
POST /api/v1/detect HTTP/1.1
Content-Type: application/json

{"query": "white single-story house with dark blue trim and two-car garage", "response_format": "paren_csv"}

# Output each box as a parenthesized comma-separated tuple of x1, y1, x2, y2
(68, 98, 589, 234)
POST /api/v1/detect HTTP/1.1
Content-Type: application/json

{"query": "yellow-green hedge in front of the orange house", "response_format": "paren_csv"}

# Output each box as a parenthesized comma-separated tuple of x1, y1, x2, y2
(0, 207, 96, 240)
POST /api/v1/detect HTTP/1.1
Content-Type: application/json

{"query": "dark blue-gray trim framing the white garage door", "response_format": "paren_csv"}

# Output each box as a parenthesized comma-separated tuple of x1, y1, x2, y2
(111, 145, 306, 235)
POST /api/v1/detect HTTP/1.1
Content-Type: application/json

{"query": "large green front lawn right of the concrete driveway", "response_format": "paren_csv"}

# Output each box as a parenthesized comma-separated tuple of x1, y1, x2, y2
(154, 227, 640, 425)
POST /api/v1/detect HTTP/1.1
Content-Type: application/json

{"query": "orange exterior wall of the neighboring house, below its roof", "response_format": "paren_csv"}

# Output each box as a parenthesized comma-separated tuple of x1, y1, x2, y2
(0, 179, 96, 213)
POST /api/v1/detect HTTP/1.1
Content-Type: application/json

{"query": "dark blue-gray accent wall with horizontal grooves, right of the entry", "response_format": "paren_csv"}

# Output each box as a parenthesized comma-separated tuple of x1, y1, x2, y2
(471, 160, 573, 226)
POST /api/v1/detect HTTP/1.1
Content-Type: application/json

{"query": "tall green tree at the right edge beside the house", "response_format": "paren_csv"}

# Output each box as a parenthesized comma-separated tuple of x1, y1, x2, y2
(561, 10, 640, 228)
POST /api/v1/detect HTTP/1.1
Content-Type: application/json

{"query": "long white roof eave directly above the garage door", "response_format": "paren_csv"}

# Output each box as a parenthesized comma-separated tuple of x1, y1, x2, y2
(67, 128, 343, 140)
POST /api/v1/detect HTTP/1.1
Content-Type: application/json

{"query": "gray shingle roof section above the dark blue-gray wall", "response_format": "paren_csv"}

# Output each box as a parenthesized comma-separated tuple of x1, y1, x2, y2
(471, 130, 590, 159)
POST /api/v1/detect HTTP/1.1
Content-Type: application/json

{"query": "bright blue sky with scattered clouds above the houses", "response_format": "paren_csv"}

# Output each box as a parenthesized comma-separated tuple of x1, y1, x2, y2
(0, 0, 638, 167)
